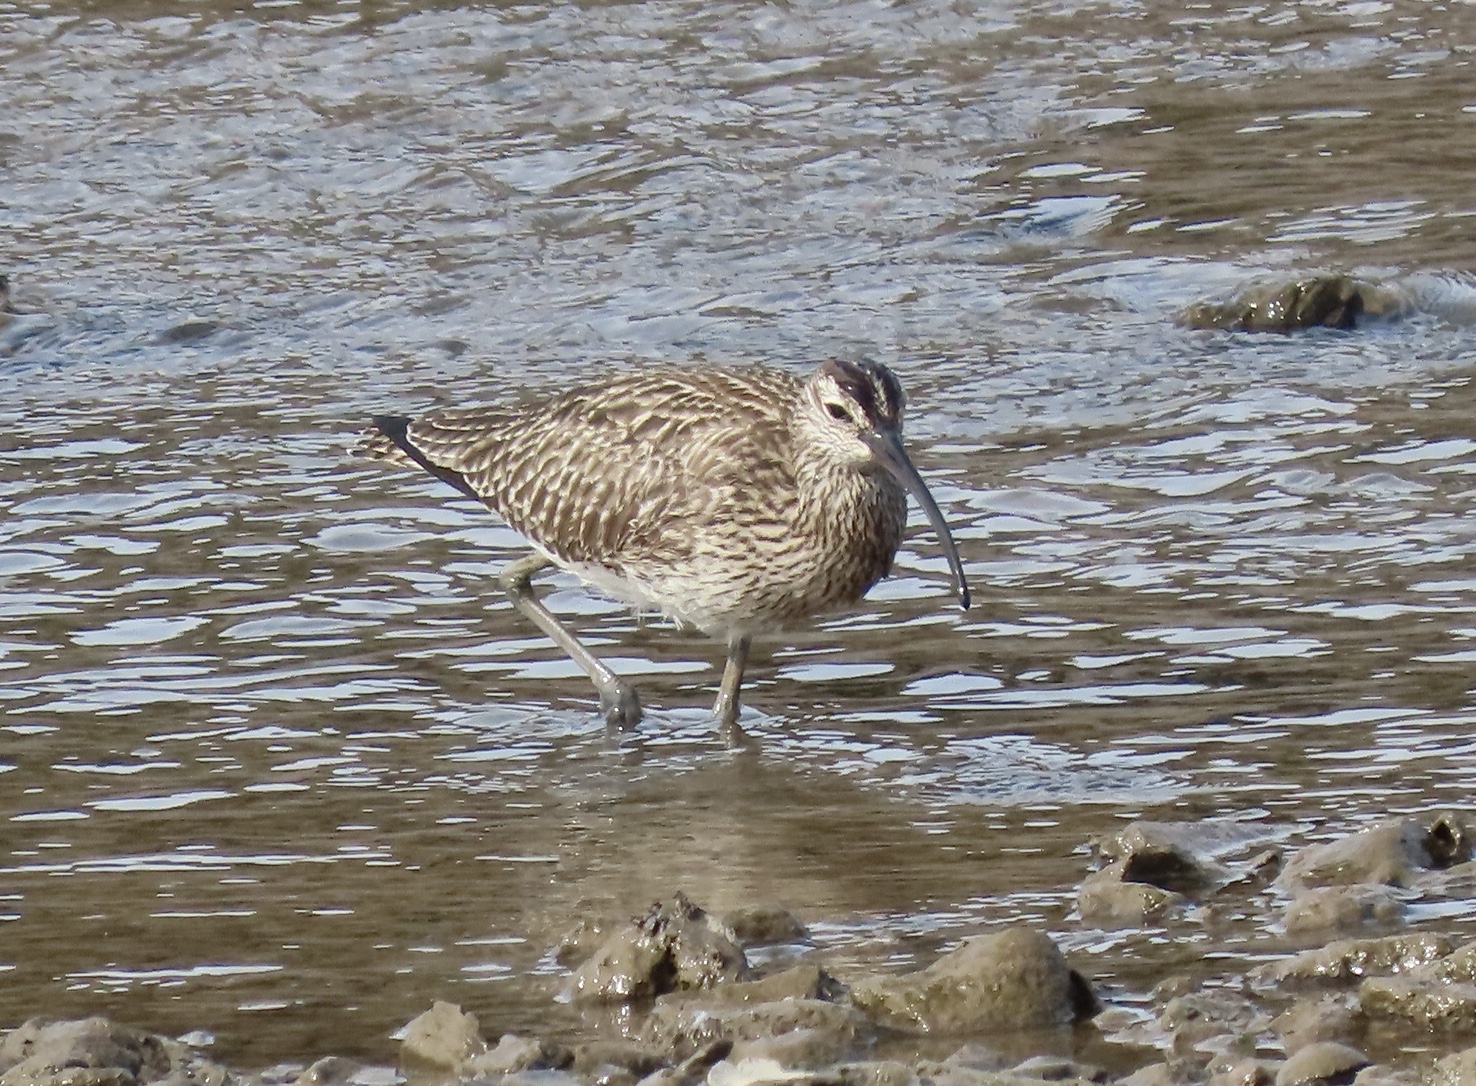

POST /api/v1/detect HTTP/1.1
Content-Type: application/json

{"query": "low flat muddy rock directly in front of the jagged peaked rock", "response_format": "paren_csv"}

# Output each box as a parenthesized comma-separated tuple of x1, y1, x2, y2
(645, 999, 875, 1052)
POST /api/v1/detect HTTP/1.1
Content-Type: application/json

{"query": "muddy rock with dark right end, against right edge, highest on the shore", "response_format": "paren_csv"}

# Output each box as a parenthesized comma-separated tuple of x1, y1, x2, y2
(1277, 815, 1470, 891)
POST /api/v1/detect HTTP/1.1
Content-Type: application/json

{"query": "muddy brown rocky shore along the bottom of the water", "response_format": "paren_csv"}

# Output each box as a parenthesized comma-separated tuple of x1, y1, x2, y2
(0, 813, 1476, 1086)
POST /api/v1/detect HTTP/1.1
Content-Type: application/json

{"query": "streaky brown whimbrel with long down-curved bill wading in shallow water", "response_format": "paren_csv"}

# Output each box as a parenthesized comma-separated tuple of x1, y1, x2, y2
(363, 362, 968, 732)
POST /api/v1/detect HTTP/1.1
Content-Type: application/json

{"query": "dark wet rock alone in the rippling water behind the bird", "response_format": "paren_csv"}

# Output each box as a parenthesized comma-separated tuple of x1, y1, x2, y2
(1179, 276, 1408, 333)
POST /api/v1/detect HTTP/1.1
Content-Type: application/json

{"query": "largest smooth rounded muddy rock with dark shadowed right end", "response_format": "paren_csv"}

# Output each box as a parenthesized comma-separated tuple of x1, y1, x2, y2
(850, 928, 1101, 1034)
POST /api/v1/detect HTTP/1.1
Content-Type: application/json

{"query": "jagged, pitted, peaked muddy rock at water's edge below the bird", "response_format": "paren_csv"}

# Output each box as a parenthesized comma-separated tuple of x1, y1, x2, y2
(564, 894, 748, 1003)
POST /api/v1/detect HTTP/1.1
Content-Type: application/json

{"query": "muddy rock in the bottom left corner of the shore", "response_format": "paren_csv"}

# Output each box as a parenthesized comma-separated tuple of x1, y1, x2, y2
(0, 1018, 188, 1086)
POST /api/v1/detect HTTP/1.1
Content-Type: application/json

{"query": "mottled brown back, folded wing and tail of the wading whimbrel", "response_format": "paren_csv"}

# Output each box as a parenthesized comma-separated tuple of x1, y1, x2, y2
(370, 370, 799, 568)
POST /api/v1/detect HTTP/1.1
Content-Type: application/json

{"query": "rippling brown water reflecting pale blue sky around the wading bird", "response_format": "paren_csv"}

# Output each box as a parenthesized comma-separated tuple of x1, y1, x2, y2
(0, 1, 1476, 1065)
